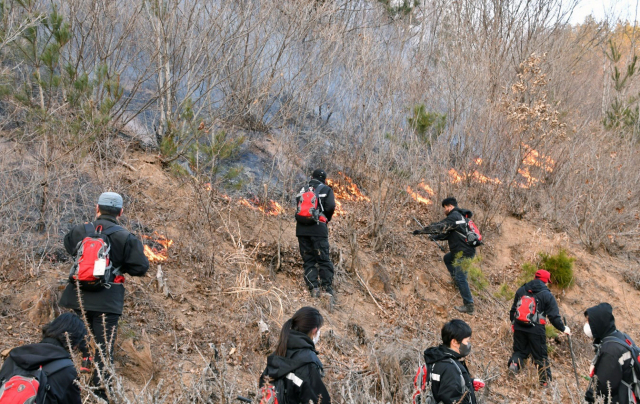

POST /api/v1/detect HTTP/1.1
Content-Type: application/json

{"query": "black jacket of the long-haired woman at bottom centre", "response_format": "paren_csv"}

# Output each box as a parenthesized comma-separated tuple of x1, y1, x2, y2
(260, 330, 331, 404)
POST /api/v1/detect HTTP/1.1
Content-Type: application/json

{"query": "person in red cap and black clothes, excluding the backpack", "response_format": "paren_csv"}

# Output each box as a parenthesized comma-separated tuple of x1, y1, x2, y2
(508, 269, 571, 386)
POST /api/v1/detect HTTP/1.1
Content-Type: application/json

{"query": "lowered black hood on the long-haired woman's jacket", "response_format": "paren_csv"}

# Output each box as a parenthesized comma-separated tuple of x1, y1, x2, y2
(267, 330, 317, 380)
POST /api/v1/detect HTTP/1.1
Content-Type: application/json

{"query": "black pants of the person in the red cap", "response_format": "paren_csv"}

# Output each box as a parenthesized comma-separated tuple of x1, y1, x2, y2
(509, 330, 551, 383)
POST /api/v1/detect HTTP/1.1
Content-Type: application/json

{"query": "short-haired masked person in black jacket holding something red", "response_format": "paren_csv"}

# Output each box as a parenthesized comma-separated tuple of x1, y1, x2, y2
(424, 319, 484, 404)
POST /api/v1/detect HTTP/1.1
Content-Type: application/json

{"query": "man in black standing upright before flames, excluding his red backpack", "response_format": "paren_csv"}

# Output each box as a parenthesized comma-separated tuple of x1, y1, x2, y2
(296, 169, 336, 297)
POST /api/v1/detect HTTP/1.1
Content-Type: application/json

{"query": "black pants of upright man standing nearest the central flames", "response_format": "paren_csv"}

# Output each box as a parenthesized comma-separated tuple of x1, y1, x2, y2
(298, 236, 333, 289)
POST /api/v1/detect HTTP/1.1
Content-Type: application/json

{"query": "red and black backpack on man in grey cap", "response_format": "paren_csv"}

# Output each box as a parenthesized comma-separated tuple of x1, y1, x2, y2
(69, 223, 125, 291)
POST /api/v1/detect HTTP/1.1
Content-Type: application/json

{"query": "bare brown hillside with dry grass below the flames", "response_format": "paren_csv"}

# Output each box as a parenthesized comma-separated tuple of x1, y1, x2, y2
(0, 152, 640, 403)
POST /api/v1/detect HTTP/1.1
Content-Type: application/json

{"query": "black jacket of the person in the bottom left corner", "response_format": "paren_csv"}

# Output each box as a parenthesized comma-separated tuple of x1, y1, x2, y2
(0, 338, 82, 404)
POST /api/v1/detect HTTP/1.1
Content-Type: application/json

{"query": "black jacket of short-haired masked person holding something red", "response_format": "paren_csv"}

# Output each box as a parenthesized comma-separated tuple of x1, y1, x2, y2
(424, 345, 477, 404)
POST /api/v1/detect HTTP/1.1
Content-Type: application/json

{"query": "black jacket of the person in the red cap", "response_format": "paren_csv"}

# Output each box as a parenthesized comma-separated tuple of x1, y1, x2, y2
(509, 279, 564, 335)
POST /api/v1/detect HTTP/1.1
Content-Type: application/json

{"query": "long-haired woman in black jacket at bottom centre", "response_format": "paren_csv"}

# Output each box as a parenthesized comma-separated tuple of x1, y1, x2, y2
(260, 307, 331, 404)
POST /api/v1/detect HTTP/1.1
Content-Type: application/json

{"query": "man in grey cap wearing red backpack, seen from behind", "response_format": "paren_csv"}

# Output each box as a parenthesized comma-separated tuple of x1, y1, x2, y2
(60, 192, 149, 401)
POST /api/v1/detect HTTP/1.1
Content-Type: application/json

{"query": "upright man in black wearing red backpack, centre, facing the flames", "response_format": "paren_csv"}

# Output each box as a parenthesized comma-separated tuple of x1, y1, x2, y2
(296, 169, 336, 298)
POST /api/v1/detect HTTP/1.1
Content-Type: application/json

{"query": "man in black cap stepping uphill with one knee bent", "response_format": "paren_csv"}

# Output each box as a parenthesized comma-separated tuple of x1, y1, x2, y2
(413, 198, 476, 314)
